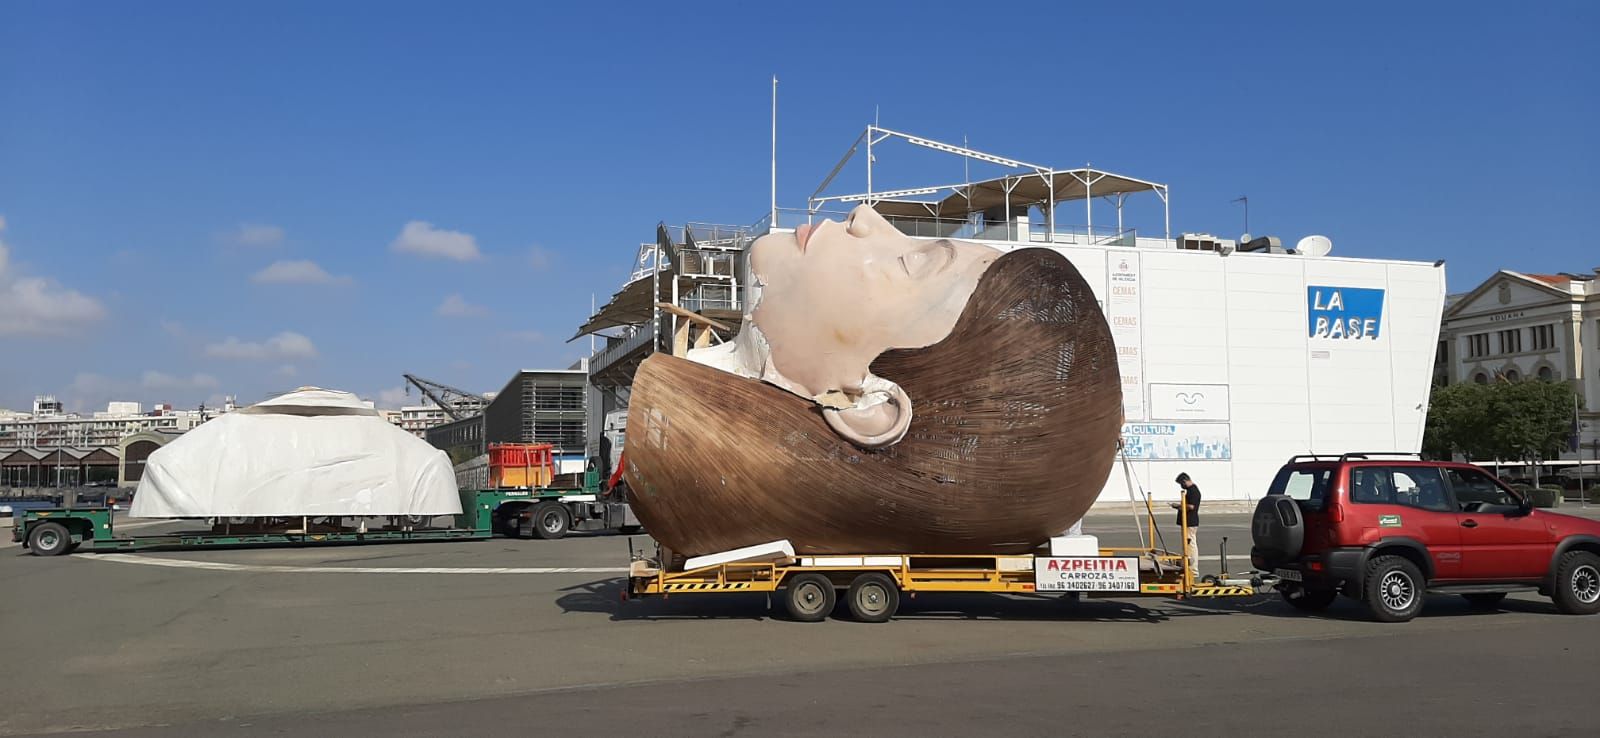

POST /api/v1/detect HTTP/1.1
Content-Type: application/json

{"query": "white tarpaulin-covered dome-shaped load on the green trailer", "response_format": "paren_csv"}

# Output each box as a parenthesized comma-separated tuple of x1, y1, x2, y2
(130, 387, 461, 517)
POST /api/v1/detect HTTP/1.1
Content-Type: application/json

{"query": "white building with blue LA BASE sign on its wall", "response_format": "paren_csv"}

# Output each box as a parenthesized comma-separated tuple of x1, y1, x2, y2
(989, 222, 1445, 503)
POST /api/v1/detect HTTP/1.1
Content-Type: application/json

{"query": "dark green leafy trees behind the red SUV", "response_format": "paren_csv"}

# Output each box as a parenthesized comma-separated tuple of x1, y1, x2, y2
(1422, 379, 1578, 461)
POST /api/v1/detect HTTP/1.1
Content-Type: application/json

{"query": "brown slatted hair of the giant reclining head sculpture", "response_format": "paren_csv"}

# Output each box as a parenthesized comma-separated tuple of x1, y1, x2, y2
(626, 248, 1122, 556)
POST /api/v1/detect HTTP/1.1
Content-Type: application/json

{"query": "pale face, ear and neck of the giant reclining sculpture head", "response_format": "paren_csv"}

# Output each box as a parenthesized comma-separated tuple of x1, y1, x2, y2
(690, 205, 1000, 448)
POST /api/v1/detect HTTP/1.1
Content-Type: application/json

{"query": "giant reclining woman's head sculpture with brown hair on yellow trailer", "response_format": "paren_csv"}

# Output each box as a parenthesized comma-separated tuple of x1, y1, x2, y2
(626, 207, 1122, 554)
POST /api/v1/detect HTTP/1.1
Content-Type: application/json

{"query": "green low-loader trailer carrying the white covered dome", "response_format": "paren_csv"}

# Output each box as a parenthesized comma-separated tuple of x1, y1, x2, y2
(11, 490, 544, 556)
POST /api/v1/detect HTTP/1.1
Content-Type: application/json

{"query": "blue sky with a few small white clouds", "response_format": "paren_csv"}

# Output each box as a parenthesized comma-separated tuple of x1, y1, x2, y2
(0, 2, 1600, 410)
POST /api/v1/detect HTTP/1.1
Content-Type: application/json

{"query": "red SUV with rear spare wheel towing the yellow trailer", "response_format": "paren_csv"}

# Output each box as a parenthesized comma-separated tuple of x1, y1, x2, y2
(1250, 453, 1600, 623)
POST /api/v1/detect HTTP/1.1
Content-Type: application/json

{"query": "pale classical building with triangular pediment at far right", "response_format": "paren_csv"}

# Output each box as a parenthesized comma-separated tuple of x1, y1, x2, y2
(1435, 269, 1600, 459)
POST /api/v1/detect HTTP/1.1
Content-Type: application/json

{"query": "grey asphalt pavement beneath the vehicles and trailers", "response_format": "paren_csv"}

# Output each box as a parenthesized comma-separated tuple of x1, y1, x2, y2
(0, 514, 1600, 735)
